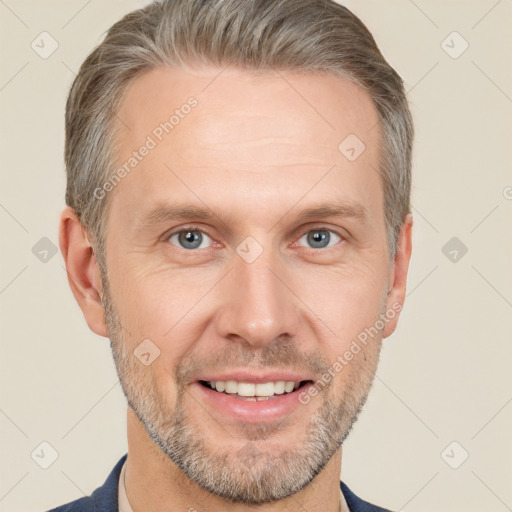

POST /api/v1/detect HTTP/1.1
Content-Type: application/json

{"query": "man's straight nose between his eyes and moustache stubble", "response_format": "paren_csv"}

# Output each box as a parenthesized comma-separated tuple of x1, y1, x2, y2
(216, 247, 298, 348)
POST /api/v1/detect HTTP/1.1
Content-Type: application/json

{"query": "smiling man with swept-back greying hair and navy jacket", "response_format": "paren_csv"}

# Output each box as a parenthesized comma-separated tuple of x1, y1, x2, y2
(54, 0, 413, 512)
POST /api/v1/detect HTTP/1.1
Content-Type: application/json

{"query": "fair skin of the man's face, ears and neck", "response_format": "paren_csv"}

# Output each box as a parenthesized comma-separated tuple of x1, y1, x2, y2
(60, 67, 412, 512)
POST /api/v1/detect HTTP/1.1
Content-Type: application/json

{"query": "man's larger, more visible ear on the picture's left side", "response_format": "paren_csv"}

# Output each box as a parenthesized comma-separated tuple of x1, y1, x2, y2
(59, 206, 108, 337)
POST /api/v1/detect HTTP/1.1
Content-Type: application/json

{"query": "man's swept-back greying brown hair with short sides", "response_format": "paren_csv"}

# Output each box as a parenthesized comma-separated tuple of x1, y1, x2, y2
(65, 0, 414, 266)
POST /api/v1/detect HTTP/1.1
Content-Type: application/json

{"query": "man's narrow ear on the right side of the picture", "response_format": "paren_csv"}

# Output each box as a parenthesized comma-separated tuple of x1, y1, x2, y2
(383, 213, 412, 338)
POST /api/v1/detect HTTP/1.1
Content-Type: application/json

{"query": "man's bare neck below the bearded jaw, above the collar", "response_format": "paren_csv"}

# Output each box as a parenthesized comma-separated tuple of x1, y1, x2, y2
(125, 408, 348, 512)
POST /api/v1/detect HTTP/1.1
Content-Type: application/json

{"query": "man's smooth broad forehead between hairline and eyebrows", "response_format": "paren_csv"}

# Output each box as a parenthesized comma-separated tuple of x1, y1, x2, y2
(108, 68, 382, 228)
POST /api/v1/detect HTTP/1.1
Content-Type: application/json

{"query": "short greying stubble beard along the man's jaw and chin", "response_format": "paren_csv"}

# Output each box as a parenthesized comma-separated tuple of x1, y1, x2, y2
(102, 273, 380, 505)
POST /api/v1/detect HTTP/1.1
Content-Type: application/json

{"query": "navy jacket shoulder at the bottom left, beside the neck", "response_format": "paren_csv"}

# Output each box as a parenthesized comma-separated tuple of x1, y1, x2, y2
(48, 454, 126, 512)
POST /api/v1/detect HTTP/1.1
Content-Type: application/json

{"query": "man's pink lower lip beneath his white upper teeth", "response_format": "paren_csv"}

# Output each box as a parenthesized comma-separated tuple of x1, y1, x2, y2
(193, 382, 313, 423)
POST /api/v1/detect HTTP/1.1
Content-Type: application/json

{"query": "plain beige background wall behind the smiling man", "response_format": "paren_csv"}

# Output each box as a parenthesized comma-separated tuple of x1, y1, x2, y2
(0, 0, 512, 512)
